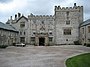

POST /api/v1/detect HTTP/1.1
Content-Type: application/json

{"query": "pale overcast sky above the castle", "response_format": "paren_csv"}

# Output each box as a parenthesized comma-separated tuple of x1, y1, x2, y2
(0, 0, 90, 23)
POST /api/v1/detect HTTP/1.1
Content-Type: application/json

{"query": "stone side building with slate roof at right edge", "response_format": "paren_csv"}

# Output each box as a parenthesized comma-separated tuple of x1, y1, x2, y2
(80, 19, 90, 45)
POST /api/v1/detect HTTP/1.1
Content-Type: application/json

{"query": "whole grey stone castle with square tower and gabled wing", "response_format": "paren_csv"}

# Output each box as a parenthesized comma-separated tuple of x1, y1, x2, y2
(6, 3, 83, 46)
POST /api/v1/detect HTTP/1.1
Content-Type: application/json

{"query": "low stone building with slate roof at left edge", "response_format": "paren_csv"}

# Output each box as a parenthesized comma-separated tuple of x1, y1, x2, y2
(0, 22, 18, 45)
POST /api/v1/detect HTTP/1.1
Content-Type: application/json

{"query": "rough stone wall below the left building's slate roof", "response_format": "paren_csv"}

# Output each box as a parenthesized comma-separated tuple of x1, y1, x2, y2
(0, 29, 18, 45)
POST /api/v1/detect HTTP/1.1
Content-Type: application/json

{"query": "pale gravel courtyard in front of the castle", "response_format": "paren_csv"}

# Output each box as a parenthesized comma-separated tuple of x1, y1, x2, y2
(0, 45, 90, 67)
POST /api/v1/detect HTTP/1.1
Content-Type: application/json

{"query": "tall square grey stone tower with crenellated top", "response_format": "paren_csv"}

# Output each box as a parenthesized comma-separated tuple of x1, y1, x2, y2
(55, 3, 83, 44)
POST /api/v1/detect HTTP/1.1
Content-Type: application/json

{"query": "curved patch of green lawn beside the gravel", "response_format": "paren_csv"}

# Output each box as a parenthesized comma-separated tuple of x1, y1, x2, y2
(66, 53, 90, 67)
